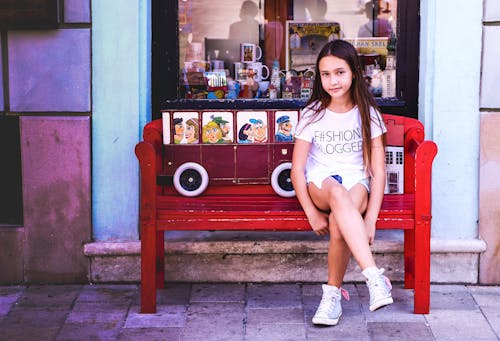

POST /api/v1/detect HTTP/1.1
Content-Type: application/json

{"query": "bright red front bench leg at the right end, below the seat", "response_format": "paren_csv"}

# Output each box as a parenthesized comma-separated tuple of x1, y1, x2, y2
(414, 221, 431, 314)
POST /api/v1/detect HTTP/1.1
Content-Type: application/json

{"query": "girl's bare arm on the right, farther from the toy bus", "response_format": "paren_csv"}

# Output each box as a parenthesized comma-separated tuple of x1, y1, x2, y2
(365, 136, 386, 245)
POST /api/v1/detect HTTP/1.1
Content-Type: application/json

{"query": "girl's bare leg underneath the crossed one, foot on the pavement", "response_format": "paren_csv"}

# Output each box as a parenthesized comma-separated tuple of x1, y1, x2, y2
(328, 185, 368, 288)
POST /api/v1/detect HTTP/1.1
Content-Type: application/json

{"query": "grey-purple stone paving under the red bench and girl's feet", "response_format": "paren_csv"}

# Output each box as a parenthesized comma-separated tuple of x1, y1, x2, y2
(0, 283, 500, 341)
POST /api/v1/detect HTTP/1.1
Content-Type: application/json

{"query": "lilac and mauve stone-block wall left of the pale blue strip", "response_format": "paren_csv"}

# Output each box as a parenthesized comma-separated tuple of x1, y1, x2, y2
(0, 0, 92, 283)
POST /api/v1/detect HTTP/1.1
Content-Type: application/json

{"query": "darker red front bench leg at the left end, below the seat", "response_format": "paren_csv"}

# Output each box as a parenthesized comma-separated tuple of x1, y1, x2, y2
(141, 224, 156, 314)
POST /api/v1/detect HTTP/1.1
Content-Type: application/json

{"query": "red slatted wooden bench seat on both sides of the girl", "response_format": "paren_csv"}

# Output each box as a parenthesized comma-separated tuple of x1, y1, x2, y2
(157, 194, 415, 231)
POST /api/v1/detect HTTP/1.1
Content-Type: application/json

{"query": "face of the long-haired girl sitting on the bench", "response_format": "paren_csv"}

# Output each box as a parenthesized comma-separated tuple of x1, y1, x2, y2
(318, 55, 353, 100)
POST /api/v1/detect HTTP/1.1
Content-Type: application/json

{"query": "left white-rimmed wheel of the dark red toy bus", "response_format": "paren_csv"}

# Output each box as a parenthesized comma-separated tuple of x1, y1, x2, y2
(174, 162, 208, 197)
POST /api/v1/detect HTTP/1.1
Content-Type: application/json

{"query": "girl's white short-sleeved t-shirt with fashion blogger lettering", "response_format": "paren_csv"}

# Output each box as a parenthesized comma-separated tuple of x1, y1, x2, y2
(295, 106, 387, 189)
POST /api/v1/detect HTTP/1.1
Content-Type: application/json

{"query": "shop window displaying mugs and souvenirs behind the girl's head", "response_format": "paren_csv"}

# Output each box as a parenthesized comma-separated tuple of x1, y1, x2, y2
(153, 0, 419, 116)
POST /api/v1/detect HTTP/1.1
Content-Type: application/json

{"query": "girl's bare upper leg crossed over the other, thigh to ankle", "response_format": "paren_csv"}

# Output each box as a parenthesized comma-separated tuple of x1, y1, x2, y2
(308, 178, 375, 271)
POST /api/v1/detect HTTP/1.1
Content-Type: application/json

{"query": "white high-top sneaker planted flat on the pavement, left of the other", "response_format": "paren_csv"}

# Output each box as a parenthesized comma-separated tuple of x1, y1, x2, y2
(312, 284, 349, 326)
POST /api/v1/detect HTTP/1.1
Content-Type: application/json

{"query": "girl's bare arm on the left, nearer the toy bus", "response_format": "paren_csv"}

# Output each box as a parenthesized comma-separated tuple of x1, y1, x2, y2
(290, 139, 328, 235)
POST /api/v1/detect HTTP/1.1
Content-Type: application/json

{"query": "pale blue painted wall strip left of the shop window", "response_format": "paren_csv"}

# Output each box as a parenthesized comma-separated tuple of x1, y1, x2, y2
(92, 0, 151, 241)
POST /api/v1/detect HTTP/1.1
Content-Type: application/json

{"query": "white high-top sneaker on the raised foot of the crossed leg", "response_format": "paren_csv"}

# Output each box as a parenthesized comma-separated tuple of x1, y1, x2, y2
(363, 268, 393, 311)
